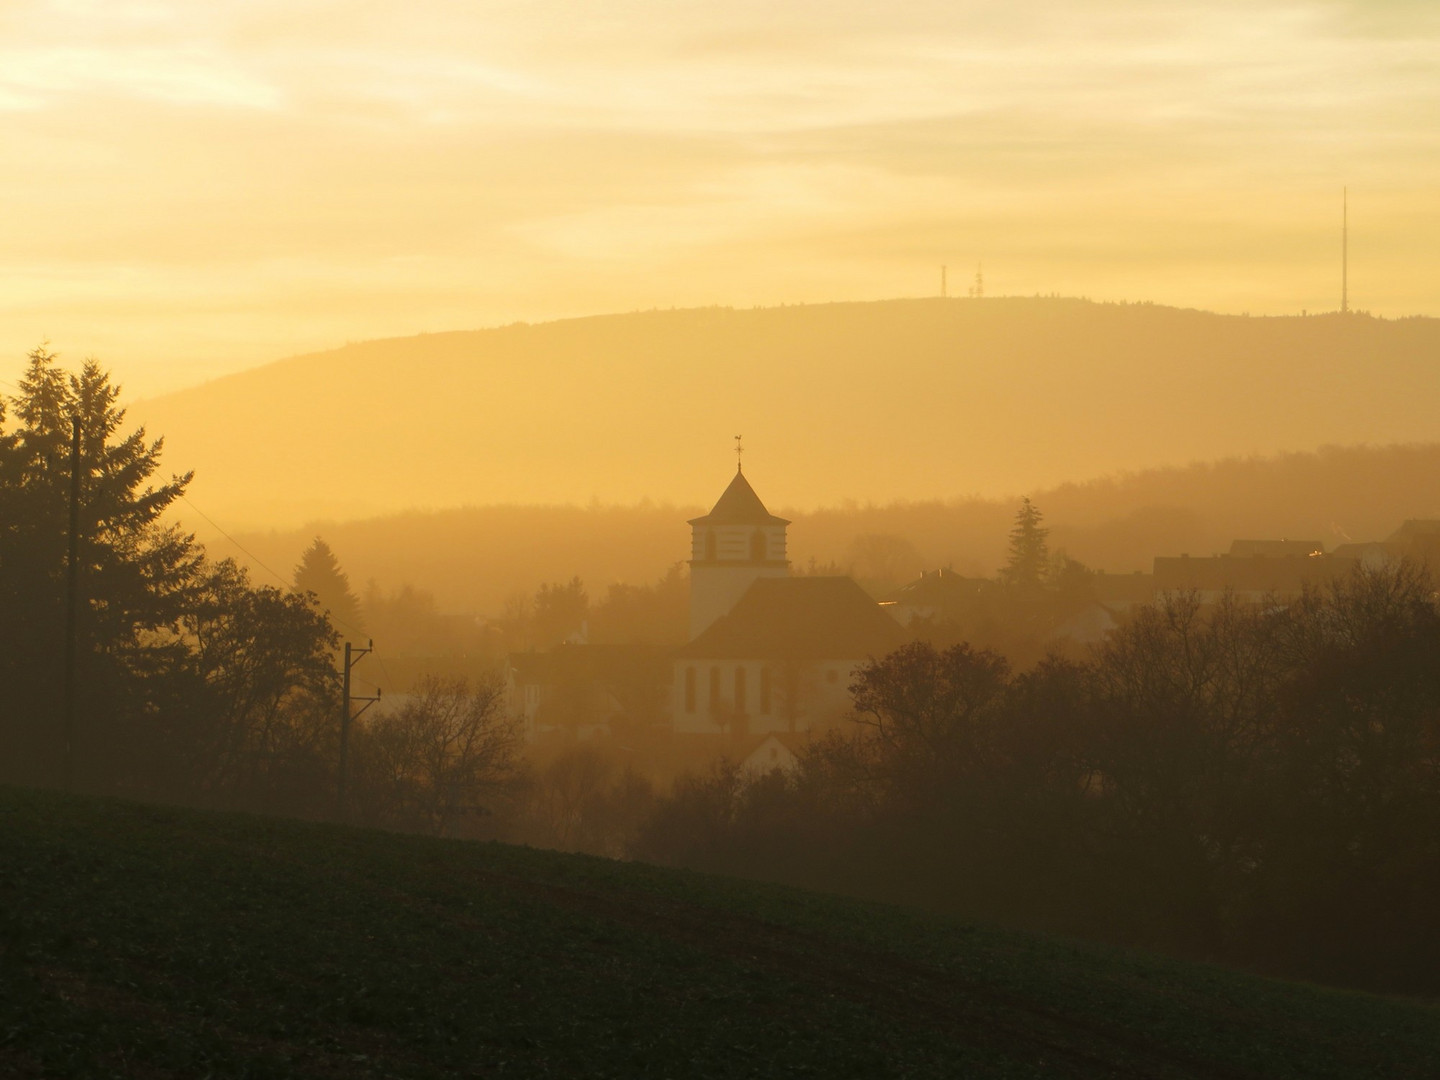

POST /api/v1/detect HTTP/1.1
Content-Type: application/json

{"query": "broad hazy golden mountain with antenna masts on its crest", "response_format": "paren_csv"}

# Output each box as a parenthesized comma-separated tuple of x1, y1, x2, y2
(131, 298, 1440, 527)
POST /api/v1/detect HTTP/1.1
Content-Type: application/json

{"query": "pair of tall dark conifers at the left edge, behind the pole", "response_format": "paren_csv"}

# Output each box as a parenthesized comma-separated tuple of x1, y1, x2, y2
(0, 347, 203, 776)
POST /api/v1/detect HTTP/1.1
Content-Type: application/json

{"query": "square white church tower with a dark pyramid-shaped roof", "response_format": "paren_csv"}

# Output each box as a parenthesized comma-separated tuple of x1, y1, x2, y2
(690, 467, 791, 641)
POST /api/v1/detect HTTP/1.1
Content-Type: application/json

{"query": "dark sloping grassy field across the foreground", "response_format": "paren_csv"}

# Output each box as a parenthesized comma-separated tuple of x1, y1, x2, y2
(0, 788, 1440, 1077)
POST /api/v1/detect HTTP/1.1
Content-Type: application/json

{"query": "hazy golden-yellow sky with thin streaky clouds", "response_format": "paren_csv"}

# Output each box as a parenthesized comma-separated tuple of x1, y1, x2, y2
(0, 0, 1440, 395)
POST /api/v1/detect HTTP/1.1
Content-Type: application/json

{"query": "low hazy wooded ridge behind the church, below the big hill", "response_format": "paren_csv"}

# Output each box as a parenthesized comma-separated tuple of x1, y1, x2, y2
(227, 444, 1440, 615)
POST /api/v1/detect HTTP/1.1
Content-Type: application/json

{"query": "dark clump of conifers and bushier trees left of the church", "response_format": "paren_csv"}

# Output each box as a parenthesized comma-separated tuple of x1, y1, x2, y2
(0, 348, 518, 832)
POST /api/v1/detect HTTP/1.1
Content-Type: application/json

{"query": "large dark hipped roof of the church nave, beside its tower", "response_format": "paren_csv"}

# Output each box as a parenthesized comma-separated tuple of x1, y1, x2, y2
(677, 577, 906, 660)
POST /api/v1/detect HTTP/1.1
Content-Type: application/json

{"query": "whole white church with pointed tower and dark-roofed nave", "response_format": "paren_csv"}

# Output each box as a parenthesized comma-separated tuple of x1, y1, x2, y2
(671, 465, 904, 737)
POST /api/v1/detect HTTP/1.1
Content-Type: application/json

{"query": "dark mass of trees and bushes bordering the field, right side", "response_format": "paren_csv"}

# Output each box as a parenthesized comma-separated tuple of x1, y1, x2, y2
(634, 564, 1440, 994)
